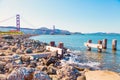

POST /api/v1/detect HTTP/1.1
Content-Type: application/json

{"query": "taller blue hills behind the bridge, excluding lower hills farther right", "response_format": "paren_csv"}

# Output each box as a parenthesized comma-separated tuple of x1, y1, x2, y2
(0, 26, 71, 35)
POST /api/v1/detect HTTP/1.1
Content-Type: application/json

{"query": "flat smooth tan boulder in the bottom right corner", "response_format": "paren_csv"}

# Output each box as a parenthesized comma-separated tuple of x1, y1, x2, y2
(85, 70, 120, 80)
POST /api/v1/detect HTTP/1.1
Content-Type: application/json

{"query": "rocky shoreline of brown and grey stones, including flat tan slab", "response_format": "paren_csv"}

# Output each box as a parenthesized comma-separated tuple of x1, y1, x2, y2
(0, 35, 120, 80)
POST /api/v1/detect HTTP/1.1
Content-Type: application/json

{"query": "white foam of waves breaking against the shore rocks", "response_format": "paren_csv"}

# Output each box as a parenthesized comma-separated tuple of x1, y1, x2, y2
(61, 51, 101, 69)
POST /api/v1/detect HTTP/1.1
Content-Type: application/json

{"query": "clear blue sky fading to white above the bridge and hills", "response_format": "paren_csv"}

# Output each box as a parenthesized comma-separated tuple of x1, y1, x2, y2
(0, 0, 120, 33)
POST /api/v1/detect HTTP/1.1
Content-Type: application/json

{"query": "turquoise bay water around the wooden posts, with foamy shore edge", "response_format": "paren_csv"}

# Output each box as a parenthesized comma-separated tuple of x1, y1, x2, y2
(31, 34, 120, 72)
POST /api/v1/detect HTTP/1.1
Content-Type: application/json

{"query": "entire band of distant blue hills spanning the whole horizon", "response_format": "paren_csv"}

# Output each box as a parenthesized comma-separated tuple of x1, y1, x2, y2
(0, 26, 120, 35)
